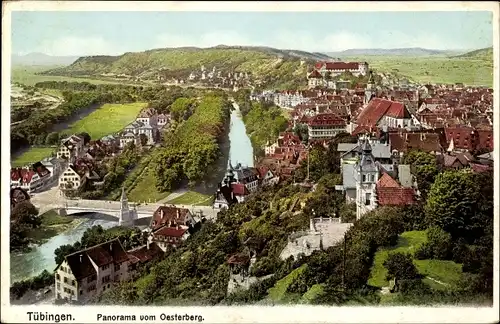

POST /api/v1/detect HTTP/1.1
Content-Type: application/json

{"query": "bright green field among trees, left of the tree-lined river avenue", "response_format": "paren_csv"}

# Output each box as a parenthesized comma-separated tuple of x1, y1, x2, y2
(70, 102, 146, 139)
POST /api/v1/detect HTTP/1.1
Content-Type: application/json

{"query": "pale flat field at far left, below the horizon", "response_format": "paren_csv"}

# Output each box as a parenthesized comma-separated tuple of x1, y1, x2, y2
(11, 66, 133, 86)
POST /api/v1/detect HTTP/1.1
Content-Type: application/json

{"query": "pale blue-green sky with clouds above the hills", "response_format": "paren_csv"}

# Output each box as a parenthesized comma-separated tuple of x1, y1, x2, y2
(12, 11, 493, 56)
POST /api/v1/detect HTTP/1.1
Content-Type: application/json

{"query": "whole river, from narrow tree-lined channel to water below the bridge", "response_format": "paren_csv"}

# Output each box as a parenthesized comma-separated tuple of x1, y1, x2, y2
(10, 100, 254, 283)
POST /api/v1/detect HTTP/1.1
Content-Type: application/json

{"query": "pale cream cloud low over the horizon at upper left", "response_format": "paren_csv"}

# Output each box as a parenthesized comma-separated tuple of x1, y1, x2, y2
(34, 36, 126, 56)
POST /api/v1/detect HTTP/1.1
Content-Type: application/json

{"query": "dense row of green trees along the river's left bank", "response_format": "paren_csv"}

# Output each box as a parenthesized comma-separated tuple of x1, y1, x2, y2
(155, 94, 230, 191)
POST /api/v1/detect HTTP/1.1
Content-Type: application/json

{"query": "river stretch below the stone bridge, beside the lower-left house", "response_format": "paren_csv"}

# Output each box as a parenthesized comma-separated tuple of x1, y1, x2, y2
(10, 213, 118, 283)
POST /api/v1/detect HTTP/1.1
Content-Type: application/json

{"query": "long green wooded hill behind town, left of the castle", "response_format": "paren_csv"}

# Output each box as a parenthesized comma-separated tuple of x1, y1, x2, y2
(43, 45, 332, 85)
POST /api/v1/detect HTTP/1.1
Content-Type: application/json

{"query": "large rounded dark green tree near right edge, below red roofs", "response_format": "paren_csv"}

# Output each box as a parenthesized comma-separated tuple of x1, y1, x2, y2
(425, 171, 481, 239)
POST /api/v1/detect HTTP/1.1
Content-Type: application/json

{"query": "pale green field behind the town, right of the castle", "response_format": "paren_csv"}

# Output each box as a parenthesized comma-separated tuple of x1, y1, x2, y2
(345, 56, 493, 87)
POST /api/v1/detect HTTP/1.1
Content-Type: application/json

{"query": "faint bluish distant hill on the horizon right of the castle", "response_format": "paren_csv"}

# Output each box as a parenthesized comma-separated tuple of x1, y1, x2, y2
(325, 47, 461, 57)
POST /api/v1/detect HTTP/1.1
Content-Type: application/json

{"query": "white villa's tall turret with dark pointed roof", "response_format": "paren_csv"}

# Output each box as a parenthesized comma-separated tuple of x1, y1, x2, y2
(355, 138, 380, 219)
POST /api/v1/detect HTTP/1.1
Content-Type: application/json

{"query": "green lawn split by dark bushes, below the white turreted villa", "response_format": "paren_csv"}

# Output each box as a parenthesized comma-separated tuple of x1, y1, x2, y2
(368, 231, 462, 289)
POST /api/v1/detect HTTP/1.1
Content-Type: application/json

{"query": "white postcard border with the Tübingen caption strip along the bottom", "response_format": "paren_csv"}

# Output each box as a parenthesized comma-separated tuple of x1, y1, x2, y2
(1, 1, 500, 323)
